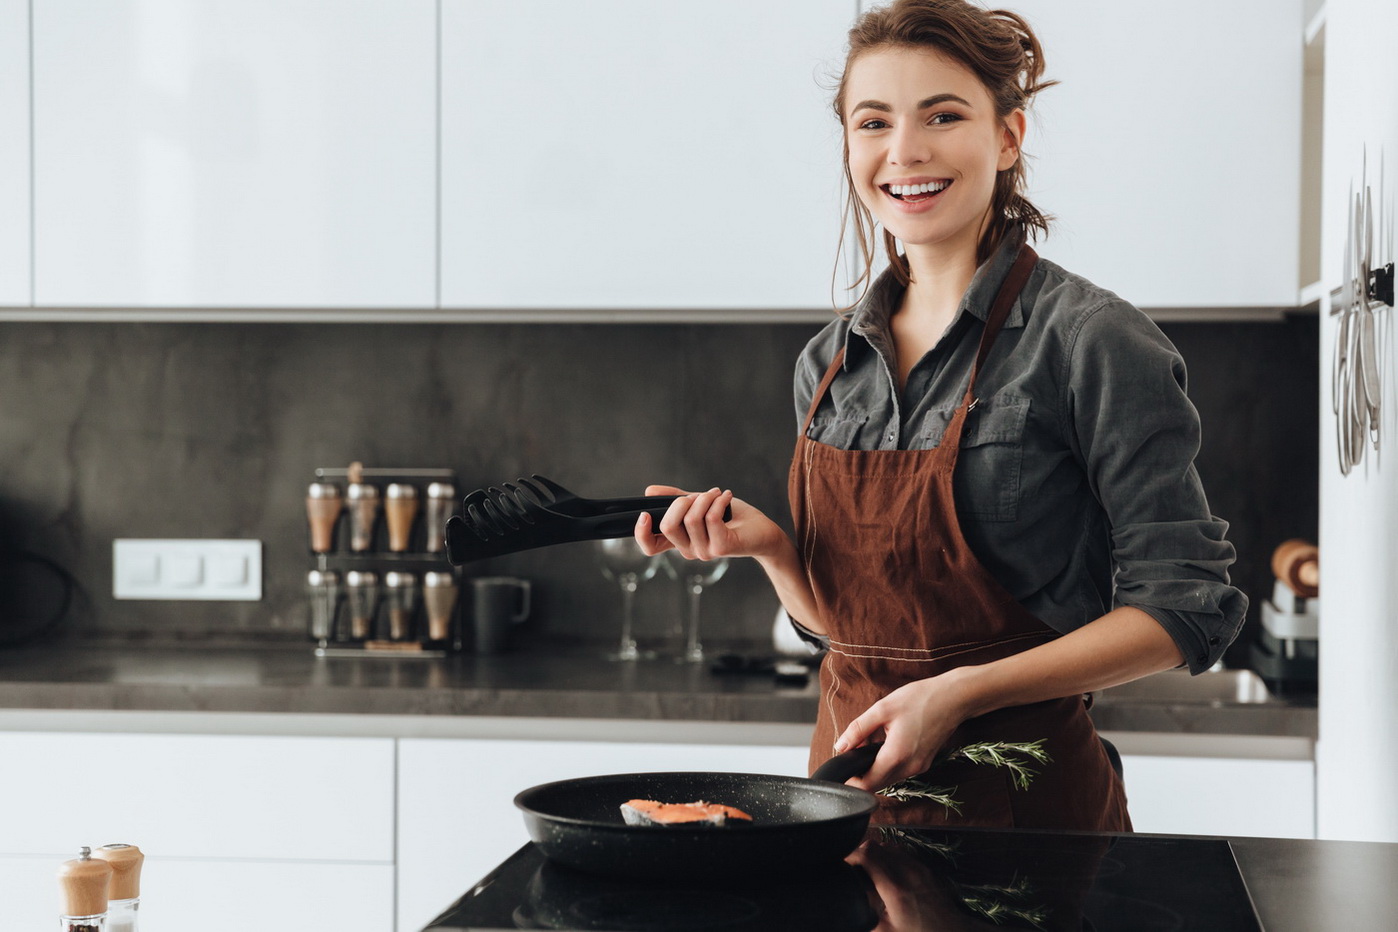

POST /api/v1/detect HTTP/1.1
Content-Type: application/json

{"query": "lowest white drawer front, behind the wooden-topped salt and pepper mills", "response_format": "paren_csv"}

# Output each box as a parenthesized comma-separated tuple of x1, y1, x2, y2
(0, 850, 394, 932)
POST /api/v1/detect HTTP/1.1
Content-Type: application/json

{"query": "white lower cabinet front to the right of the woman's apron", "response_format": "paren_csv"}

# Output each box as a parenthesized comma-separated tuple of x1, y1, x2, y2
(1121, 755, 1316, 838)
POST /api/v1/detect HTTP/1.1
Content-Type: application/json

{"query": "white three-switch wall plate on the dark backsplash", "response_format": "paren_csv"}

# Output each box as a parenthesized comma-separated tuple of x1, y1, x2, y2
(112, 538, 261, 602)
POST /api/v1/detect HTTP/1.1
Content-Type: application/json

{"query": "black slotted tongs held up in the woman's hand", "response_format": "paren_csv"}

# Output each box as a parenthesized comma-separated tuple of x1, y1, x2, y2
(446, 474, 733, 566)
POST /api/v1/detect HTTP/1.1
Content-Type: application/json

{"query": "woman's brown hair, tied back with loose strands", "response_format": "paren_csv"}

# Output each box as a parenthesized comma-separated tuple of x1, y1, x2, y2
(832, 0, 1060, 313)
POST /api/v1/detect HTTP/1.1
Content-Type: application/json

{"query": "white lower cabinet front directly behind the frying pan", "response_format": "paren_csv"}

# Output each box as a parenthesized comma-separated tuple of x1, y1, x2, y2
(398, 739, 808, 932)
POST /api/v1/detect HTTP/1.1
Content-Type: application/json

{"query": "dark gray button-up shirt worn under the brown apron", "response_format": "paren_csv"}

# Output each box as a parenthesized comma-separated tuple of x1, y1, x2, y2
(795, 225, 1248, 673)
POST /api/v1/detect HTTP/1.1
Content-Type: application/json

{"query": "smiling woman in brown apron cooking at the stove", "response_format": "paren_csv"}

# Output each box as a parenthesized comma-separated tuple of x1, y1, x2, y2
(636, 0, 1247, 831)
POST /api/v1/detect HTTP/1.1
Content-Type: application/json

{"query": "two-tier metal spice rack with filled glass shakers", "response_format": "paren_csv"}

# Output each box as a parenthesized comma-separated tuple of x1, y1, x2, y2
(306, 463, 463, 658)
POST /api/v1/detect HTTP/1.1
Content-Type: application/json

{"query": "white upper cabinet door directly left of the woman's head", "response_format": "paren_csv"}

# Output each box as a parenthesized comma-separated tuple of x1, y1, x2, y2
(442, 0, 854, 309)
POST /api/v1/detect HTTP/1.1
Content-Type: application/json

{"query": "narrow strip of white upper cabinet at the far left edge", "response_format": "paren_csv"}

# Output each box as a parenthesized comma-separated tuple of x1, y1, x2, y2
(0, 0, 29, 306)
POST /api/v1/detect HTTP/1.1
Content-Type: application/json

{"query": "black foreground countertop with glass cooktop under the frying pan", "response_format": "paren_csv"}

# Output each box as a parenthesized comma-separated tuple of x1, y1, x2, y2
(428, 829, 1398, 932)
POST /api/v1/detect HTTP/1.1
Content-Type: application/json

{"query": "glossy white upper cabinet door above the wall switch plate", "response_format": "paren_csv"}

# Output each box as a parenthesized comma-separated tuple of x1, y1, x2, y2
(34, 0, 436, 307)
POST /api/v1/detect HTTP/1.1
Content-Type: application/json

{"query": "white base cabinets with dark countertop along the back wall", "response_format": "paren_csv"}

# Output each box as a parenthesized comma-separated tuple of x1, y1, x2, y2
(0, 639, 1316, 932)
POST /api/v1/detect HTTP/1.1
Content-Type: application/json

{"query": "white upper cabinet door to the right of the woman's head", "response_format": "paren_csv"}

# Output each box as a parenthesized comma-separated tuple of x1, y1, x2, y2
(1014, 0, 1314, 307)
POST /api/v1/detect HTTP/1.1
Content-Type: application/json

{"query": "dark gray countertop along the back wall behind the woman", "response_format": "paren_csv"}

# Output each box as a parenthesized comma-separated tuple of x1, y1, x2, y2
(0, 641, 1317, 738)
